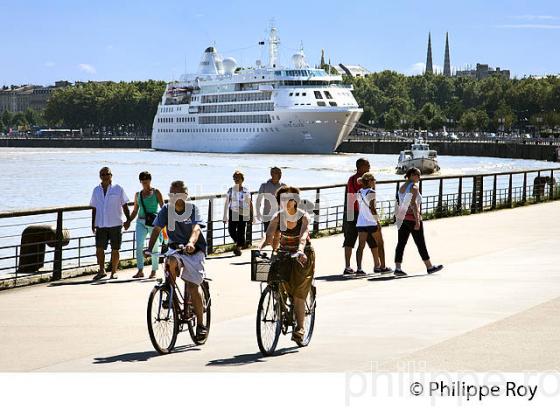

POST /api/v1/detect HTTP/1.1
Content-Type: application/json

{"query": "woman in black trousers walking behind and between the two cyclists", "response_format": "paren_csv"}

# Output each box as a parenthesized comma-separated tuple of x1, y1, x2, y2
(223, 171, 253, 256)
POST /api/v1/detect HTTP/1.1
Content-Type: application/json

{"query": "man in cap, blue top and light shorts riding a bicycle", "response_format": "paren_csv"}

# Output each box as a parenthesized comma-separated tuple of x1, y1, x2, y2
(144, 181, 208, 339)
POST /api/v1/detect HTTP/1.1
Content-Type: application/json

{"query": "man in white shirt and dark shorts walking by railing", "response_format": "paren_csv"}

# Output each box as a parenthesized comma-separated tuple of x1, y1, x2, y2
(89, 167, 130, 280)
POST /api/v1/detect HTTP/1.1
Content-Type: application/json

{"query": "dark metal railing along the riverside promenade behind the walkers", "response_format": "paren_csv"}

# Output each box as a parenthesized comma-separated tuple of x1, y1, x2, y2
(0, 168, 560, 288)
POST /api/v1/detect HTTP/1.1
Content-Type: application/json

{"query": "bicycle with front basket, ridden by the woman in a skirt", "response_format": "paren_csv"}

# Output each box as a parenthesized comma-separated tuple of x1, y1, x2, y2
(251, 250, 317, 356)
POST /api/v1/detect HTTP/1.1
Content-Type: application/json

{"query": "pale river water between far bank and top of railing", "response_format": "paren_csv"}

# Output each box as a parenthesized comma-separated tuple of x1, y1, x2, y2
(0, 148, 554, 211)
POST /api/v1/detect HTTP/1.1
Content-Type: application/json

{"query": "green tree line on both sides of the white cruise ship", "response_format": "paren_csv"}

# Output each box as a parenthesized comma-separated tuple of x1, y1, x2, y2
(0, 71, 560, 134)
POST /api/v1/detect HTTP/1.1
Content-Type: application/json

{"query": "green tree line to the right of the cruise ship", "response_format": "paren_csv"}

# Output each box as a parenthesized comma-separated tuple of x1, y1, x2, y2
(345, 71, 560, 131)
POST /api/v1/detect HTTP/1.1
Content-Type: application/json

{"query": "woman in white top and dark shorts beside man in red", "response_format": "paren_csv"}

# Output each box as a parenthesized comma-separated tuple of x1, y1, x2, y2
(356, 172, 393, 276)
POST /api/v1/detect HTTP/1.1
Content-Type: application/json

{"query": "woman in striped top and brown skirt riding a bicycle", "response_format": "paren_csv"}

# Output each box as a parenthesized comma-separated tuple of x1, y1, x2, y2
(259, 186, 315, 342)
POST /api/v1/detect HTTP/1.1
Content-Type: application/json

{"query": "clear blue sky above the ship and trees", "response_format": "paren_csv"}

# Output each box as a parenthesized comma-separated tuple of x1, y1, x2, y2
(0, 0, 560, 85)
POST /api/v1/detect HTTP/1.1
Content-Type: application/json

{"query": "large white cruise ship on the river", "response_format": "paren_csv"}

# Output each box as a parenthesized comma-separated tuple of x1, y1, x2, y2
(152, 27, 363, 154)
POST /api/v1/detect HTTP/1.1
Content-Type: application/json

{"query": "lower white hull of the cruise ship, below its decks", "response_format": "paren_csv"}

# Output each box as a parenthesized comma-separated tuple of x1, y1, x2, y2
(152, 108, 363, 154)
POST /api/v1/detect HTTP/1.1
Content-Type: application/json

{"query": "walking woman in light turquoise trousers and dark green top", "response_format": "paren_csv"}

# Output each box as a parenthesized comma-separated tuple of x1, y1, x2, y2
(130, 171, 163, 279)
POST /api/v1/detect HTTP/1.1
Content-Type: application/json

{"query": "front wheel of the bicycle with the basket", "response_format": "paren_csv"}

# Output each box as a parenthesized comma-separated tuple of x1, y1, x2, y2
(257, 286, 282, 356)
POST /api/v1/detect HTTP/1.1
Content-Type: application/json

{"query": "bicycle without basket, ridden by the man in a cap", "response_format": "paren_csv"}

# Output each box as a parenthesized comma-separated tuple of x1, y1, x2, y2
(147, 245, 211, 354)
